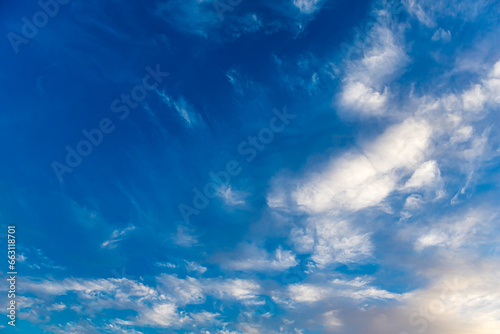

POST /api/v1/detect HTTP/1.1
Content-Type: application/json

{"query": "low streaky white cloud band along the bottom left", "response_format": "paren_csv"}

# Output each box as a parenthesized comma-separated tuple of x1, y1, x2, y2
(20, 274, 261, 333)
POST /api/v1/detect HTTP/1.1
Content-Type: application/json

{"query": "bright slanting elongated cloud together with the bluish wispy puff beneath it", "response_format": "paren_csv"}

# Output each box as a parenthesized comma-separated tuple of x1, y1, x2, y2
(268, 118, 435, 268)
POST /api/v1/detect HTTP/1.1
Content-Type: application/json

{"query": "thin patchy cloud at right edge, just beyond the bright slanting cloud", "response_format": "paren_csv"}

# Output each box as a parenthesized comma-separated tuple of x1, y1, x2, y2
(390, 62, 500, 204)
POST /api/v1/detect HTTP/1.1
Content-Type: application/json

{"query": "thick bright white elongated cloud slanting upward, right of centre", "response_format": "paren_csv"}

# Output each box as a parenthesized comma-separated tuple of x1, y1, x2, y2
(286, 119, 432, 213)
